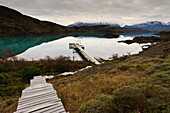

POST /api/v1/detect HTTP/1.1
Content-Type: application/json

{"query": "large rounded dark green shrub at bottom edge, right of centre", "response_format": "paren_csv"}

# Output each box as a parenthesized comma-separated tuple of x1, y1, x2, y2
(113, 83, 147, 113)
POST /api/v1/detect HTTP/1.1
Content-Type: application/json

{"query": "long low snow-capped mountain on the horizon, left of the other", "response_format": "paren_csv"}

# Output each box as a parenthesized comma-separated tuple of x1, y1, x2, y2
(68, 22, 120, 27)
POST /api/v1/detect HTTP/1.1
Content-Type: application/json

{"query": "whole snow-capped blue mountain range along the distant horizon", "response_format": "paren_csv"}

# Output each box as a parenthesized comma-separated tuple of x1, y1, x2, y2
(68, 21, 170, 31)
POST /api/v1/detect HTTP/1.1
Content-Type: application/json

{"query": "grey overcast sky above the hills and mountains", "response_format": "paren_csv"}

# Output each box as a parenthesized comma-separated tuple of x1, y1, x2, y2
(0, 0, 170, 25)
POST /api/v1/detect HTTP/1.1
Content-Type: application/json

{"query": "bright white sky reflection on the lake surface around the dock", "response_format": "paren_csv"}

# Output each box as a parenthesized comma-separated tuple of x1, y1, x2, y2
(17, 36, 149, 60)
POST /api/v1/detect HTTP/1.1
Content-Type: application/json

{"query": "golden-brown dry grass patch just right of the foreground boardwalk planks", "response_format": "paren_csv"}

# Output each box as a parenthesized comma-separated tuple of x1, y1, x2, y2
(54, 74, 145, 112)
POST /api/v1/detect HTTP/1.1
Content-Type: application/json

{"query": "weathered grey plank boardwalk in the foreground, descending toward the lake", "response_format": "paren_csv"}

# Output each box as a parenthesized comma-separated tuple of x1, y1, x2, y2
(14, 76, 66, 113)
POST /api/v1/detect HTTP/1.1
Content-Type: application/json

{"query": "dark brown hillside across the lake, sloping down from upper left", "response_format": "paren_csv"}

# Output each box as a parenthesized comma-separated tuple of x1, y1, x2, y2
(0, 6, 148, 37)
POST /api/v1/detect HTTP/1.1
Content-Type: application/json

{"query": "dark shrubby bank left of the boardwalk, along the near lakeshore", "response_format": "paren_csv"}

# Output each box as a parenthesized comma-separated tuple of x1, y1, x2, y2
(0, 56, 91, 113)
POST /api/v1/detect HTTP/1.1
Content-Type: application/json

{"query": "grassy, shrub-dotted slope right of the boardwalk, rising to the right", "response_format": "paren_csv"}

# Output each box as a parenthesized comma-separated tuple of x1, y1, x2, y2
(51, 41, 170, 113)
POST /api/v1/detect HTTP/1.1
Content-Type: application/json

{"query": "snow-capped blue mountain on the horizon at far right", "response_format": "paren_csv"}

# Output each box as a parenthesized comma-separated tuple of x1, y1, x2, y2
(124, 21, 170, 31)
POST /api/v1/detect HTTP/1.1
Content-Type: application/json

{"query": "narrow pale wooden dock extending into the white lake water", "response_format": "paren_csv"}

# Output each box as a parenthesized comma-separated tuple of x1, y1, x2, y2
(69, 43, 100, 64)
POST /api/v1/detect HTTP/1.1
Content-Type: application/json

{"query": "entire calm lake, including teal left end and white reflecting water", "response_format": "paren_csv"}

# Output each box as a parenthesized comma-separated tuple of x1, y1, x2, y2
(0, 35, 154, 60)
